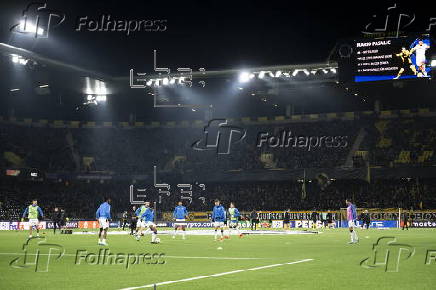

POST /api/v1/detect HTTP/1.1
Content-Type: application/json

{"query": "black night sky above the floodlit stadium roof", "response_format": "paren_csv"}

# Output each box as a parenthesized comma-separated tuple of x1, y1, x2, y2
(0, 0, 428, 75)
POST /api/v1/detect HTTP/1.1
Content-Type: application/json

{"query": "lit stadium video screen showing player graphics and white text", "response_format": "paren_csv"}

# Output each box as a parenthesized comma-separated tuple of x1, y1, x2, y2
(353, 35, 432, 82)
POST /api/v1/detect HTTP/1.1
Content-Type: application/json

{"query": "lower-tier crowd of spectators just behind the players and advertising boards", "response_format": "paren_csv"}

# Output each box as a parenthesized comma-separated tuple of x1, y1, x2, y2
(0, 178, 436, 219)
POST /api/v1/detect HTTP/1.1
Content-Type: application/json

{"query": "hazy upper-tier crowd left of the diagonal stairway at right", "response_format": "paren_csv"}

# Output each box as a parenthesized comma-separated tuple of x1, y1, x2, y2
(0, 121, 359, 174)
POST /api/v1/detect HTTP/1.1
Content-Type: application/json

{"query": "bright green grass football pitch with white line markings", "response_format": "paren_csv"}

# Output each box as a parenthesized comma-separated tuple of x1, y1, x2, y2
(0, 229, 436, 289)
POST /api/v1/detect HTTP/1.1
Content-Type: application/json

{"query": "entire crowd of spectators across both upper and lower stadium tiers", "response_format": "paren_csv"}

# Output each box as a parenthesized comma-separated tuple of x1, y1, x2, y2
(0, 118, 436, 219)
